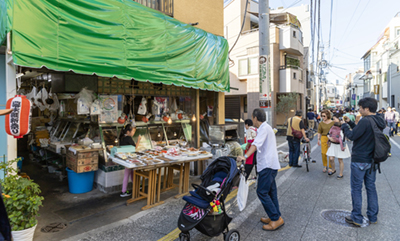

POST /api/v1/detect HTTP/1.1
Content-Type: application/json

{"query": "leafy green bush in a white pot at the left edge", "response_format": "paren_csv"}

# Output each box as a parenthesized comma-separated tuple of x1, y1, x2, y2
(0, 158, 43, 241)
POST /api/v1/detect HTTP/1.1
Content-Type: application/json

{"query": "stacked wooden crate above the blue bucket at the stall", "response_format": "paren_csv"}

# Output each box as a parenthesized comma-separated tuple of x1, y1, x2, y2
(66, 150, 99, 173)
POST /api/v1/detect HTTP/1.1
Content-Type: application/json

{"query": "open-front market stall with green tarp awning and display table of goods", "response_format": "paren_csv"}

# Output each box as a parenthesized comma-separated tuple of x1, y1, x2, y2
(0, 0, 229, 212)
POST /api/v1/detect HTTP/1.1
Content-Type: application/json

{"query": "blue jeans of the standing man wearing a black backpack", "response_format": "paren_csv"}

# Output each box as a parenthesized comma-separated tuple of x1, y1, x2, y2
(350, 162, 379, 224)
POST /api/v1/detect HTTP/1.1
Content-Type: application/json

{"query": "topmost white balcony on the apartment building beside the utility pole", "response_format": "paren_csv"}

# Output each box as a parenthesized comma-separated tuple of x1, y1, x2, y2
(279, 25, 304, 55)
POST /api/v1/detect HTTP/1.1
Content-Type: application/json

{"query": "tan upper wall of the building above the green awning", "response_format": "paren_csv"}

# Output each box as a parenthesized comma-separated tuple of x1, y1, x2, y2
(174, 0, 224, 36)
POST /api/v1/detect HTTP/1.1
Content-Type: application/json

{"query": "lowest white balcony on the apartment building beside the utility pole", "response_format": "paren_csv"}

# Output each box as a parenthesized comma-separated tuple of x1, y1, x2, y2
(279, 66, 304, 94)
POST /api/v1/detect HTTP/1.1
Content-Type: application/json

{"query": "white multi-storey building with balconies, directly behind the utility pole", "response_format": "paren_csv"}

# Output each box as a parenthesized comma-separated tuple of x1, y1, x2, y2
(224, 0, 313, 126)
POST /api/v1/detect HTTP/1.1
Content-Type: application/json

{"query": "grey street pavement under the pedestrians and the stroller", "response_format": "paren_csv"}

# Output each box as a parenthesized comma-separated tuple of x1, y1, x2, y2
(61, 136, 400, 241)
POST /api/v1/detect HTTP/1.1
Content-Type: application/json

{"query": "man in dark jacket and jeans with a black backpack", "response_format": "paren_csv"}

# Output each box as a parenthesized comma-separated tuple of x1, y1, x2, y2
(342, 97, 385, 226)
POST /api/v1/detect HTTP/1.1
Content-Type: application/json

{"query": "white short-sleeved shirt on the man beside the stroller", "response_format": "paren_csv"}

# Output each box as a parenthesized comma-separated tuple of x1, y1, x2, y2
(251, 122, 281, 172)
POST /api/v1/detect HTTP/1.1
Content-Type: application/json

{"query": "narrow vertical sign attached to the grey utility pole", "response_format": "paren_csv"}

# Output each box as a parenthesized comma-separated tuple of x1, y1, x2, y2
(258, 55, 271, 107)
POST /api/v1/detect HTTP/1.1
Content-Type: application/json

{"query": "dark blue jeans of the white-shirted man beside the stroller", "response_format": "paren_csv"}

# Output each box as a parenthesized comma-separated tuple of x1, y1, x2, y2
(257, 168, 281, 221)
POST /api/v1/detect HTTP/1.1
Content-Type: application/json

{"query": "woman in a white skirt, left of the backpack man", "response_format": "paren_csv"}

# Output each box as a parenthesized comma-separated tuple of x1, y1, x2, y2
(326, 114, 351, 179)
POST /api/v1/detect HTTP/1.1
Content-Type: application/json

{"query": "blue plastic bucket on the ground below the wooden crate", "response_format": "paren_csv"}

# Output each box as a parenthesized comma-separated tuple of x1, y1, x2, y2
(67, 167, 94, 194)
